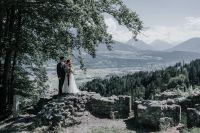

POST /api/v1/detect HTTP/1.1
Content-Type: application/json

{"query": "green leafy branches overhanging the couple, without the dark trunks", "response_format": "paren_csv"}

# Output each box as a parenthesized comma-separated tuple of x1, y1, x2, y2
(27, 0, 142, 63)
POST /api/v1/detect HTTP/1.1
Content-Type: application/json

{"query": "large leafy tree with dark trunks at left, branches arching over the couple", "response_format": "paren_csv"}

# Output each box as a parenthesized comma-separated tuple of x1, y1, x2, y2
(0, 0, 142, 118)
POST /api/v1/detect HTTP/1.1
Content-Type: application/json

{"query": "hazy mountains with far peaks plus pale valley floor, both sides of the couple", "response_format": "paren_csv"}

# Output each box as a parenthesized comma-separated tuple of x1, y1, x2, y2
(47, 38, 200, 88)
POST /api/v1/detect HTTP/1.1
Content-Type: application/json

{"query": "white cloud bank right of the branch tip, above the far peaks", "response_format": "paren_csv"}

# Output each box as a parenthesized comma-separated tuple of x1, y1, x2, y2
(139, 17, 200, 44)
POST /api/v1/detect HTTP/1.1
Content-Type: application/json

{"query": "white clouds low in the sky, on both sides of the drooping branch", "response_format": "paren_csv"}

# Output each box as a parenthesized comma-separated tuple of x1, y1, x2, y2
(105, 15, 200, 44)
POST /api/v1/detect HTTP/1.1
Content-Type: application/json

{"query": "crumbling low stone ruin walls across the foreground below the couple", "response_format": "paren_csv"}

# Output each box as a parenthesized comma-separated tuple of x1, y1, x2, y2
(32, 92, 200, 130)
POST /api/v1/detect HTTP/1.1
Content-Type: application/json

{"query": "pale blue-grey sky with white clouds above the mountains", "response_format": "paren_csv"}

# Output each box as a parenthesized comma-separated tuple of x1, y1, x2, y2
(105, 0, 200, 45)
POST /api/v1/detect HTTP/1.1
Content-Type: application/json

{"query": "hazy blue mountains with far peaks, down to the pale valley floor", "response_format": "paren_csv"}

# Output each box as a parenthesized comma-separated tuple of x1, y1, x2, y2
(80, 38, 200, 68)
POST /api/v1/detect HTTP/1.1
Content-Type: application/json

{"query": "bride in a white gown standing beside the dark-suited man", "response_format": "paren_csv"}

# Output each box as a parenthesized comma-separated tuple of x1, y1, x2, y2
(62, 60, 80, 93)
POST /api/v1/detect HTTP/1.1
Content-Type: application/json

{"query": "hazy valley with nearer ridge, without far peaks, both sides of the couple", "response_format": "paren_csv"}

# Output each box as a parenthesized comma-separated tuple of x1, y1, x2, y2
(47, 38, 200, 95)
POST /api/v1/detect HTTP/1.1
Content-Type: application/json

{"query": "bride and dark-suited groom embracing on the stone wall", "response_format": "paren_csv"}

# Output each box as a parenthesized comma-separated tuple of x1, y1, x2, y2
(57, 57, 80, 95)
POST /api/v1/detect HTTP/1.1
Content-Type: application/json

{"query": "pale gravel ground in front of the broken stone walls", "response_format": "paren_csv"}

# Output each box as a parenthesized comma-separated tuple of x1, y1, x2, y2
(63, 113, 179, 133)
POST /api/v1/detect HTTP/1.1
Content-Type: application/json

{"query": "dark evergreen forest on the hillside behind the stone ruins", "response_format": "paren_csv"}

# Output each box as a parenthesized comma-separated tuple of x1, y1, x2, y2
(80, 59, 200, 100)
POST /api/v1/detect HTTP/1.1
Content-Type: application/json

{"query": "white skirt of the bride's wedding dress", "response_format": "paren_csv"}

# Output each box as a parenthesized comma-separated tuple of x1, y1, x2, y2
(62, 70, 80, 93)
